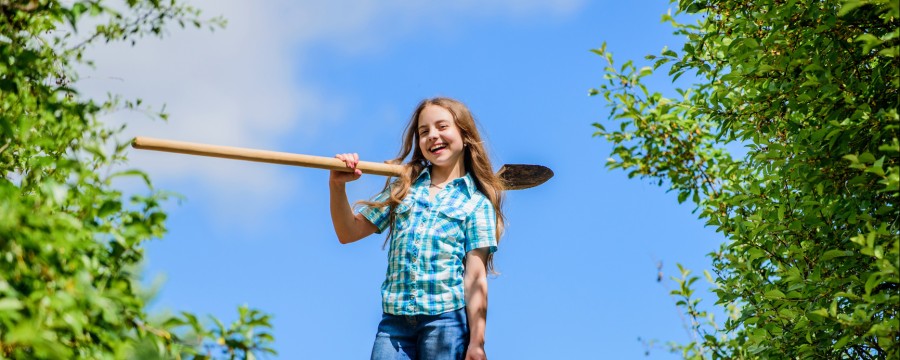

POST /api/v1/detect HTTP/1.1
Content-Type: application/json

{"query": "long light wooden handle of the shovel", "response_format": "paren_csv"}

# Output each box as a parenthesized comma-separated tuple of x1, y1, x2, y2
(131, 136, 404, 176)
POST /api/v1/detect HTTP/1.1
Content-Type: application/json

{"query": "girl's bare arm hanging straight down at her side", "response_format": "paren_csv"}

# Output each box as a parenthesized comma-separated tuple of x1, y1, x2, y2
(464, 248, 488, 360)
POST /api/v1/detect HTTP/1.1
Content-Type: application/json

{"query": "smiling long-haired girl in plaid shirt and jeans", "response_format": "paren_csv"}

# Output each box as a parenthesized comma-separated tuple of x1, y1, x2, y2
(329, 98, 503, 360)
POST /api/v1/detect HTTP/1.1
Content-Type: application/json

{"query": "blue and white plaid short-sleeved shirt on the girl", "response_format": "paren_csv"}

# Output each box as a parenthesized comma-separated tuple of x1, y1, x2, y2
(358, 168, 497, 315)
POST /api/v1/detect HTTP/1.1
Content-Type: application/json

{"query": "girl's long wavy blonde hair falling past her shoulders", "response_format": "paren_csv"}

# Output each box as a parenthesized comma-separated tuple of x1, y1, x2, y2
(359, 97, 505, 273)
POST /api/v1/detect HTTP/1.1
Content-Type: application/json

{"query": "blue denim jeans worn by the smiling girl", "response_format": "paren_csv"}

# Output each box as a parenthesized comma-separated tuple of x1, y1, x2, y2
(372, 308, 469, 360)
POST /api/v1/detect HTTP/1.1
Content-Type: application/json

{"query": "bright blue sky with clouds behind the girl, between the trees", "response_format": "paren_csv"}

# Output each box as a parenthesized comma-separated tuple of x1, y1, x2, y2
(81, 0, 722, 359)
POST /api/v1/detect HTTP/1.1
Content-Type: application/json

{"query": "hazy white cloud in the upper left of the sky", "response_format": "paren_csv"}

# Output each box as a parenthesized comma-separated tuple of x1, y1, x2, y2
(78, 0, 582, 228)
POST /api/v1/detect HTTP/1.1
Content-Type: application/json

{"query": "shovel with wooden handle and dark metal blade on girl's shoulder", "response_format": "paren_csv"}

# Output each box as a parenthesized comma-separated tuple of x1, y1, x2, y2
(131, 136, 553, 190)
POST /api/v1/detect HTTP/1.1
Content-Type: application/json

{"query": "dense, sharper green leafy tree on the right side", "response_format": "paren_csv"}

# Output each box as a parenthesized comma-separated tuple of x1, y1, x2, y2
(591, 0, 900, 359)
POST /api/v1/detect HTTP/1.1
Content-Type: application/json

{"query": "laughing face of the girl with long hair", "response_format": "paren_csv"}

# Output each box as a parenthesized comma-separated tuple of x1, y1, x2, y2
(417, 105, 465, 169)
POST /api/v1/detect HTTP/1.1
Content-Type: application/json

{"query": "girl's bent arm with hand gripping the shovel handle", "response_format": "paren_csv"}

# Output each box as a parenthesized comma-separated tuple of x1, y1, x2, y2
(328, 154, 378, 244)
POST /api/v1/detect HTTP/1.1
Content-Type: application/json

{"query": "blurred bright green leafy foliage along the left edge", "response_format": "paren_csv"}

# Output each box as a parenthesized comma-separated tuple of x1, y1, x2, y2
(0, 0, 274, 359)
